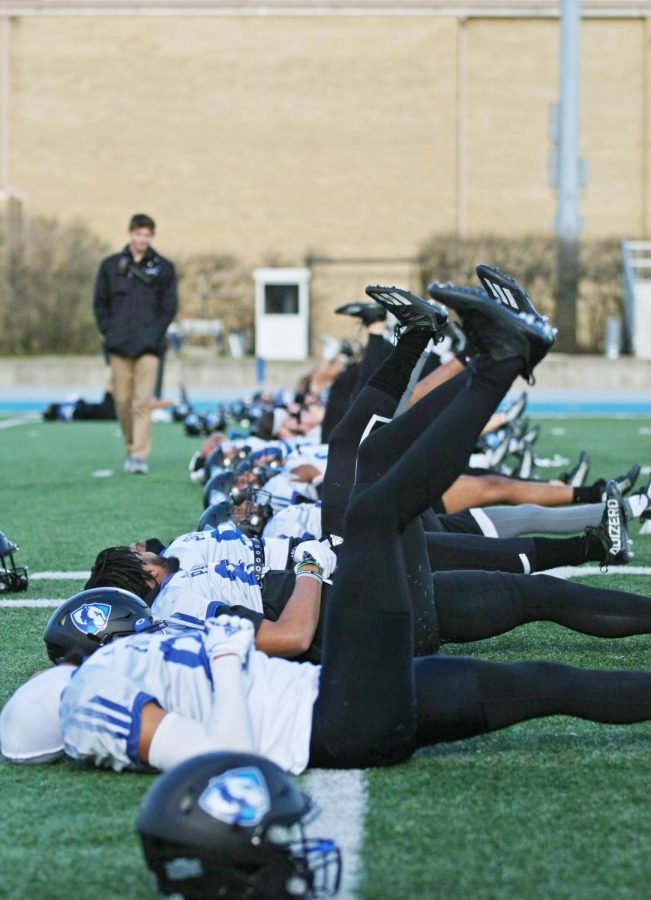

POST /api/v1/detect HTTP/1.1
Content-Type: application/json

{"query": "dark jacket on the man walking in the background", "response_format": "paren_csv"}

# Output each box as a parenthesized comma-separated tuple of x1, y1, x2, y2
(93, 246, 177, 359)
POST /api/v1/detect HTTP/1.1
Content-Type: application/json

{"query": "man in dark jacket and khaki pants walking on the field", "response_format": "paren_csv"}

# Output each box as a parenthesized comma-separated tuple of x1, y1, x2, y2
(94, 213, 177, 475)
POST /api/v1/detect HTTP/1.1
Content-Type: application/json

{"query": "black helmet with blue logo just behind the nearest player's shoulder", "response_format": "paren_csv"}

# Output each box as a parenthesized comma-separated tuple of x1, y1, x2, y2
(43, 587, 165, 663)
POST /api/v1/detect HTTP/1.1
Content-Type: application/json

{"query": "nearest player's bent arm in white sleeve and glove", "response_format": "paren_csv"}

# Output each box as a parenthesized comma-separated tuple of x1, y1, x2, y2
(138, 616, 255, 771)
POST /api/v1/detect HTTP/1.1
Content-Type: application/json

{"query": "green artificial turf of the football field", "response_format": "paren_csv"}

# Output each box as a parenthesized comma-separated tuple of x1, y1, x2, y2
(0, 418, 651, 900)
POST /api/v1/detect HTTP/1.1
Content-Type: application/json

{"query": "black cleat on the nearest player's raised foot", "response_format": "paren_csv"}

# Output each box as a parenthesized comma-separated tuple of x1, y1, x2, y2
(427, 281, 556, 381)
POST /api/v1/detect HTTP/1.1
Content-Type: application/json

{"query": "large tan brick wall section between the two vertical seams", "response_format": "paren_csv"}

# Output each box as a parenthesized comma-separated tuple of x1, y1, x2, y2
(11, 18, 455, 264)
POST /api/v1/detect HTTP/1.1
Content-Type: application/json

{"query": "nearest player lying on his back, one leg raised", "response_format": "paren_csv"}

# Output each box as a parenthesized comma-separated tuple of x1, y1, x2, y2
(11, 288, 651, 772)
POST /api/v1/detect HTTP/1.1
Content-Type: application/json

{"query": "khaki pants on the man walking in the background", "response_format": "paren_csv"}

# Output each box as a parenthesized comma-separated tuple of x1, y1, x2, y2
(109, 353, 158, 459)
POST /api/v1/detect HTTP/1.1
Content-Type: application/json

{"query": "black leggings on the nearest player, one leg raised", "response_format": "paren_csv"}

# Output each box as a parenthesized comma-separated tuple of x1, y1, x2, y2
(310, 360, 651, 768)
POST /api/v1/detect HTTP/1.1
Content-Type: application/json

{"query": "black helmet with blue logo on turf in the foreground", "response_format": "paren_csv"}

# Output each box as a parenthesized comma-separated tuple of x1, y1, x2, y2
(136, 753, 341, 900)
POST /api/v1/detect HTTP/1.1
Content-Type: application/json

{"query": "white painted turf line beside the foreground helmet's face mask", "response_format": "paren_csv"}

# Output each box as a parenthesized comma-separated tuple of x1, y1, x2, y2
(306, 769, 366, 900)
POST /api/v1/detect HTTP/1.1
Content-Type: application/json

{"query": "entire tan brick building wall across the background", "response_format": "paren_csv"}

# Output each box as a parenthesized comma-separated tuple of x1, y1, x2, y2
(1, 15, 651, 352)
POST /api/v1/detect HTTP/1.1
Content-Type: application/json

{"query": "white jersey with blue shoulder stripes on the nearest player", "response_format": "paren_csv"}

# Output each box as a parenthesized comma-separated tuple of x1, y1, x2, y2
(61, 631, 320, 774)
